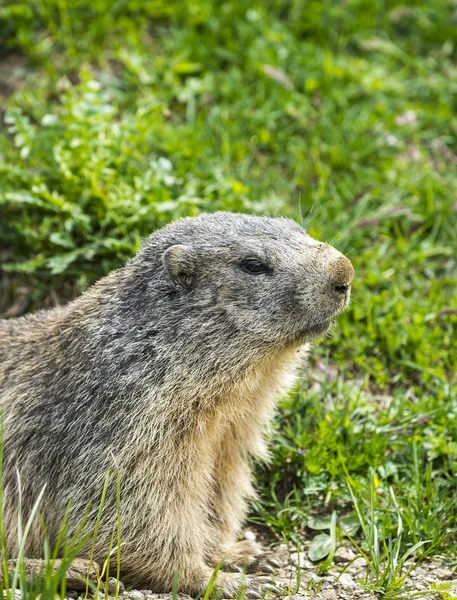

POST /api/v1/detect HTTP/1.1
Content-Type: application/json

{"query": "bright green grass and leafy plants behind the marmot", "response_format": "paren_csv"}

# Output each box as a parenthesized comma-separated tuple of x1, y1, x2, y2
(0, 0, 457, 594)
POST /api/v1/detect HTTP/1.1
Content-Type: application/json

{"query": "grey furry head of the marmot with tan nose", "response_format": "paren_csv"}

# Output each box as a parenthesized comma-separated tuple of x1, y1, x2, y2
(134, 212, 354, 347)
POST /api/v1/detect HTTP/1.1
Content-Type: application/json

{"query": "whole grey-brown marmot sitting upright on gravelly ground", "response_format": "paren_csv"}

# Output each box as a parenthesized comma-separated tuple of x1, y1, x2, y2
(0, 212, 354, 597)
